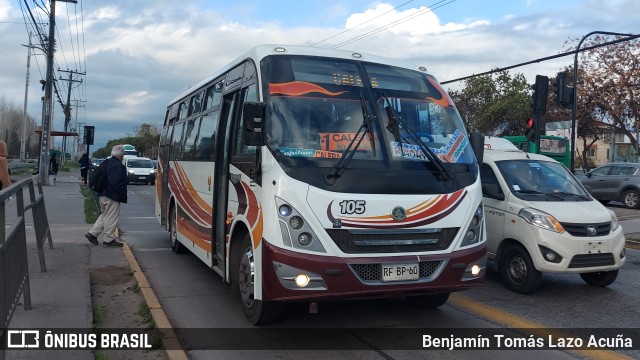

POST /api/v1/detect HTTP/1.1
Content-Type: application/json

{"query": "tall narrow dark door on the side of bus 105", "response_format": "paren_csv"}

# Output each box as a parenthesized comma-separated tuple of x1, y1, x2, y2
(212, 91, 239, 273)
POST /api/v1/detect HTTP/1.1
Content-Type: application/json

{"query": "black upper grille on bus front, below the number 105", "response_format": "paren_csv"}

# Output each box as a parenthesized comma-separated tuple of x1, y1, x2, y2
(327, 228, 460, 254)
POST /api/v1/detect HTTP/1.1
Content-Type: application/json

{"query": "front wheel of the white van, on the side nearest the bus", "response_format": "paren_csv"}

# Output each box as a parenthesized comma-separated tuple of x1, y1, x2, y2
(500, 245, 542, 294)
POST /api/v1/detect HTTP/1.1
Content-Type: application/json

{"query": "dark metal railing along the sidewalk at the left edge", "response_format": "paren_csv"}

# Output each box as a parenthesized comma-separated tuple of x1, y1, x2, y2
(0, 176, 53, 359)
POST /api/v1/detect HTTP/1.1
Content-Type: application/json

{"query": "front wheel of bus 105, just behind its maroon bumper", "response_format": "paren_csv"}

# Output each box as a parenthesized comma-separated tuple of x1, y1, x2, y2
(234, 234, 282, 325)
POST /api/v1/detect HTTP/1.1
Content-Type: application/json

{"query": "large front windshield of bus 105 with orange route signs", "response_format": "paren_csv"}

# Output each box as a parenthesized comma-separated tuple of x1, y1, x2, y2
(262, 56, 477, 193)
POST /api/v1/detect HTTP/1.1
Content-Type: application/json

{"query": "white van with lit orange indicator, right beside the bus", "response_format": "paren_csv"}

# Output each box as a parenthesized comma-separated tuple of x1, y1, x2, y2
(480, 137, 625, 294)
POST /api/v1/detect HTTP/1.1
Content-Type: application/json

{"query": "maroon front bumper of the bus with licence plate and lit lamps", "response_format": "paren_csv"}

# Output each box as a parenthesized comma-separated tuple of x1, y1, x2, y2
(262, 241, 486, 301)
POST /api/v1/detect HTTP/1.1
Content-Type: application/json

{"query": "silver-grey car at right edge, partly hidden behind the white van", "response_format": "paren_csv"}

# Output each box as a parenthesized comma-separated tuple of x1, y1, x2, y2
(577, 163, 640, 209)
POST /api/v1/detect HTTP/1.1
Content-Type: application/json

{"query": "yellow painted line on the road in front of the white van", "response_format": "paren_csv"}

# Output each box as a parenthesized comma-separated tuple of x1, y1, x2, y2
(447, 293, 633, 360)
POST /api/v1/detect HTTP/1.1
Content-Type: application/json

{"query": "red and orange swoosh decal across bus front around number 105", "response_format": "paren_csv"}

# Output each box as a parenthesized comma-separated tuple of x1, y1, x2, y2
(327, 189, 467, 229)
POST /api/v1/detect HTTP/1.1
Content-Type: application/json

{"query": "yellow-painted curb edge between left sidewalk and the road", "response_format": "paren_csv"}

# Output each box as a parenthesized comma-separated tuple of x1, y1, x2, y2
(122, 242, 189, 360)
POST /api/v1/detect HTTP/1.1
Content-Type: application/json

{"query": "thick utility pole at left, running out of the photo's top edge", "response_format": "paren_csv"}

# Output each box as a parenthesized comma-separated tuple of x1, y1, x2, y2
(38, 0, 78, 185)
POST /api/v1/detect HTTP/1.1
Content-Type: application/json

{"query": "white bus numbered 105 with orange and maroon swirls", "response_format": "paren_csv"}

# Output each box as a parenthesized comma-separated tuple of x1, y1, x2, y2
(156, 45, 486, 324)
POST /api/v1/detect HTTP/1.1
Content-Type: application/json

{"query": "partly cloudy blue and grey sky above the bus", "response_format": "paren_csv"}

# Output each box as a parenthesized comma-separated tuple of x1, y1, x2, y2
(0, 0, 640, 151)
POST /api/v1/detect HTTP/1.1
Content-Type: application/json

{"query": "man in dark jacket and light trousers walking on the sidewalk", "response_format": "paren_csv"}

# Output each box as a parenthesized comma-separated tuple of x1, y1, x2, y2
(84, 145, 129, 247)
